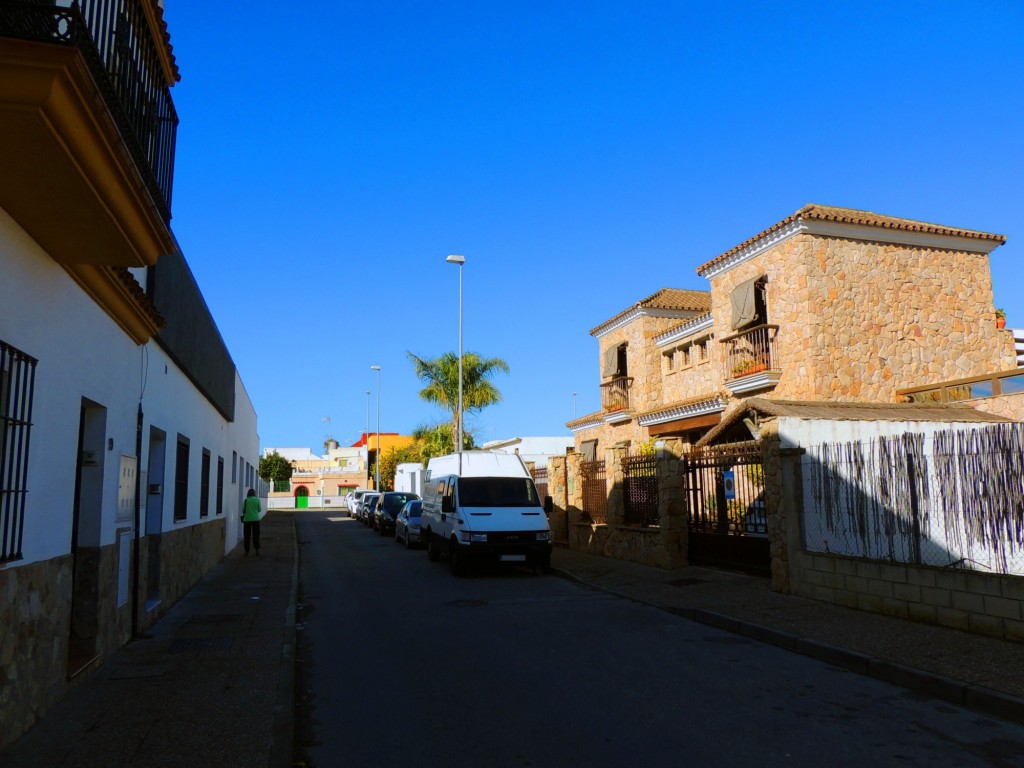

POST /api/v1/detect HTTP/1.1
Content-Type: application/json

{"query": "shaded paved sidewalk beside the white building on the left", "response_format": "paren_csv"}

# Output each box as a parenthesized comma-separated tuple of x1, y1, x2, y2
(0, 511, 298, 768)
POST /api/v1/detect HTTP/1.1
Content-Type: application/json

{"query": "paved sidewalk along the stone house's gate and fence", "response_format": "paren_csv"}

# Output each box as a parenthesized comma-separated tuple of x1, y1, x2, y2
(552, 548, 1024, 723)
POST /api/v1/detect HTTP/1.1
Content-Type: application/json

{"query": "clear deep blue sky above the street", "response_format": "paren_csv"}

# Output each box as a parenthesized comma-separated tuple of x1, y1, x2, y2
(159, 0, 1024, 453)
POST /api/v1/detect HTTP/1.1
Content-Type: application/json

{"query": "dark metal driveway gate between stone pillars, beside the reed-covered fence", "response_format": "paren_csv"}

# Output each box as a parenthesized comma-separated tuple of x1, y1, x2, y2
(683, 440, 771, 574)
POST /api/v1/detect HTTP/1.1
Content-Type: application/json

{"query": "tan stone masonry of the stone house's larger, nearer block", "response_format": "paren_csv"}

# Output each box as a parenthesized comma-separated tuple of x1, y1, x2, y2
(712, 234, 1015, 402)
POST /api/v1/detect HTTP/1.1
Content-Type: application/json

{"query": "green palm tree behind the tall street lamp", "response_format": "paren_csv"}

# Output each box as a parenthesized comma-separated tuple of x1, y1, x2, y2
(409, 352, 509, 447)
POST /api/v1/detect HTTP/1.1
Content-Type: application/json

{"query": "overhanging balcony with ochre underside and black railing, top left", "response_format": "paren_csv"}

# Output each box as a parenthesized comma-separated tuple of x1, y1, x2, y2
(0, 0, 178, 270)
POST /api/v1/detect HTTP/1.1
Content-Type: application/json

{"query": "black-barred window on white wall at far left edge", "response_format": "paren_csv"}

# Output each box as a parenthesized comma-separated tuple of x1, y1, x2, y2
(0, 341, 38, 562)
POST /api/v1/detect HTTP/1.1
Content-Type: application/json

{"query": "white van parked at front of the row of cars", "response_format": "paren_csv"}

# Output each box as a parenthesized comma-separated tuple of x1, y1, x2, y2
(420, 451, 551, 574)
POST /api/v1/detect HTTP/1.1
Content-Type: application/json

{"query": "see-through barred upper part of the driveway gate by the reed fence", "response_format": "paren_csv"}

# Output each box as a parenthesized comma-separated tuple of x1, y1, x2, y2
(684, 440, 768, 537)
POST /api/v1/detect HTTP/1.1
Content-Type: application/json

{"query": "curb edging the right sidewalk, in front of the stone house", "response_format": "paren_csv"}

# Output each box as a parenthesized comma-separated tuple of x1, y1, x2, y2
(551, 567, 1024, 725)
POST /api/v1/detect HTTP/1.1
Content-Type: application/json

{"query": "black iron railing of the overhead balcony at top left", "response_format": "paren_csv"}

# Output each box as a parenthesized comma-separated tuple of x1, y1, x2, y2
(0, 0, 178, 223)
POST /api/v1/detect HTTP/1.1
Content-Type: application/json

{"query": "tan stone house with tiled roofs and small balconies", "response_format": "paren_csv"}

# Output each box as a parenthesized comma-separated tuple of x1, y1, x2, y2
(567, 205, 1017, 458)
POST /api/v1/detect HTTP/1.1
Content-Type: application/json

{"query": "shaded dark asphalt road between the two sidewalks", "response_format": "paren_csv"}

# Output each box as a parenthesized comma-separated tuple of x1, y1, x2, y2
(296, 510, 1024, 768)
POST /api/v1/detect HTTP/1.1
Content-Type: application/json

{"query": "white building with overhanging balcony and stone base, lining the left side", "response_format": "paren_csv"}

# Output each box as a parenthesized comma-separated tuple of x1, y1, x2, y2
(0, 0, 260, 745)
